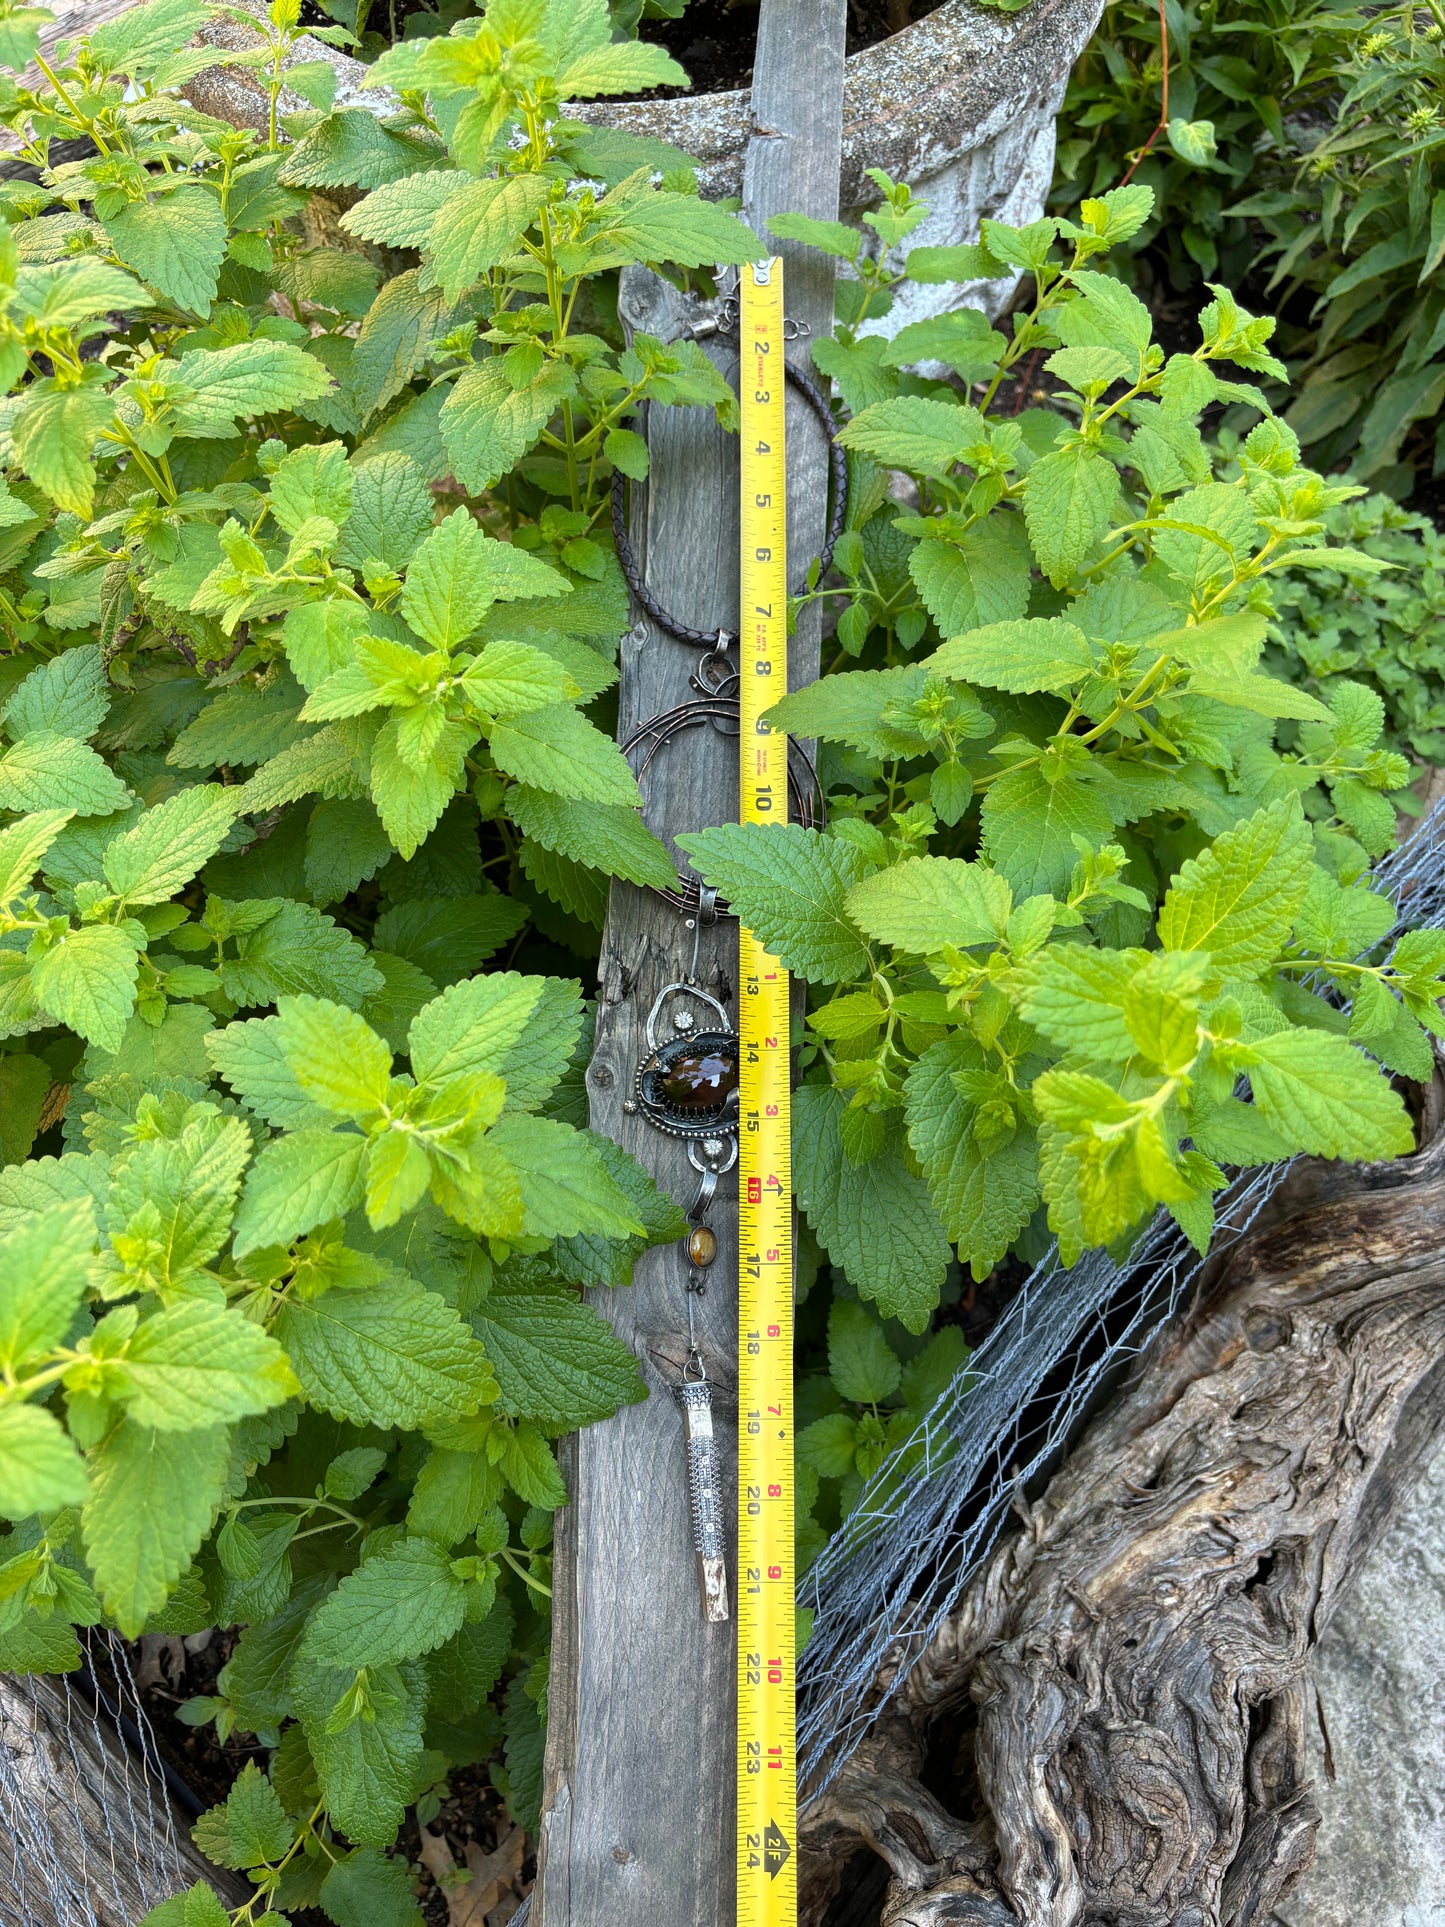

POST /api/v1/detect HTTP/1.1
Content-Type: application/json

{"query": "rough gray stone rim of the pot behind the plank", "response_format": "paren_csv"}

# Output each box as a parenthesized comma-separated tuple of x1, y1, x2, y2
(187, 0, 1102, 208)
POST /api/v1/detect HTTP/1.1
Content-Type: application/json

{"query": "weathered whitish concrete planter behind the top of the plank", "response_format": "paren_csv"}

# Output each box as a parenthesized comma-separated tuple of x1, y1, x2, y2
(187, 0, 1102, 331)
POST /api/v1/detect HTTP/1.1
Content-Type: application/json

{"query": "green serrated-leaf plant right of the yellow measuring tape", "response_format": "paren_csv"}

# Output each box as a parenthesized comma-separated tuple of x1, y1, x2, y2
(680, 181, 1445, 1356)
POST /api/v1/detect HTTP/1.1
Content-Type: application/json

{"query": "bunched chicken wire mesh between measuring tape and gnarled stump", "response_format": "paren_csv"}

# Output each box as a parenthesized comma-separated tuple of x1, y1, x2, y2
(798, 802, 1445, 1794)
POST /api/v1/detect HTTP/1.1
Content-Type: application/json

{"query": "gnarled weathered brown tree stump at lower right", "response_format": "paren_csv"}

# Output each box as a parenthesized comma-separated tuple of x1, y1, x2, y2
(803, 1087, 1445, 1927)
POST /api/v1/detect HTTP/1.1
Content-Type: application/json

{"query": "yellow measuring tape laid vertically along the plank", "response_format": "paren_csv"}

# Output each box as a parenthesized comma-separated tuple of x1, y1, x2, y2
(738, 260, 798, 1927)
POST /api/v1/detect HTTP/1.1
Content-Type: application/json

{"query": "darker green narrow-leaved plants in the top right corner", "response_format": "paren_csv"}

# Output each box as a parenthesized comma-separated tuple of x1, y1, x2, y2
(1054, 0, 1445, 495)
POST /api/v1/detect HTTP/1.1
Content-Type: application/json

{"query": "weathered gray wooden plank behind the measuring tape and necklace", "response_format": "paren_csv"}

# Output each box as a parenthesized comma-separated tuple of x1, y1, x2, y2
(532, 0, 844, 1927)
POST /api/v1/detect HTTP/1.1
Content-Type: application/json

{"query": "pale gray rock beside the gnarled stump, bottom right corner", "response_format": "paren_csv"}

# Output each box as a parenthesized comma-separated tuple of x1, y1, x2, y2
(1275, 1449, 1445, 1927)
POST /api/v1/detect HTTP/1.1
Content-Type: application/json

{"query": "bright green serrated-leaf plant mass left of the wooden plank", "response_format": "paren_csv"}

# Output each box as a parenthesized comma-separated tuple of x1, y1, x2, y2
(0, 0, 757, 1927)
